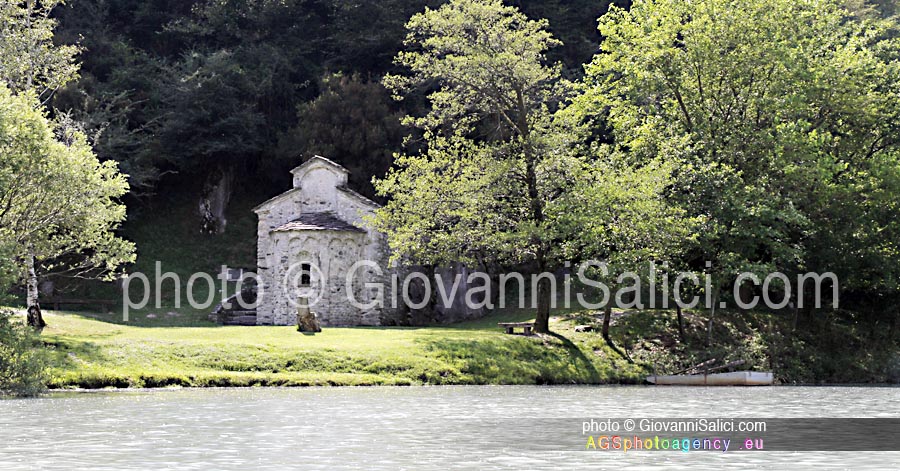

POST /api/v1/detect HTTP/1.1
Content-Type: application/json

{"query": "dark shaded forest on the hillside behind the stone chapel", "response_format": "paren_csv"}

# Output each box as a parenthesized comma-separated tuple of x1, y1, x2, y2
(49, 0, 606, 210)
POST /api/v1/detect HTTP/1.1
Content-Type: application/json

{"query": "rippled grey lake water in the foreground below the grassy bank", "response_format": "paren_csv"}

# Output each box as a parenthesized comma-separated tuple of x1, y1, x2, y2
(0, 386, 900, 470)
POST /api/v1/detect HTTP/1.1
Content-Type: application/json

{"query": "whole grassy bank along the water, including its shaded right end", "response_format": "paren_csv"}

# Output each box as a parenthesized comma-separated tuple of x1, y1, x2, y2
(26, 304, 900, 388)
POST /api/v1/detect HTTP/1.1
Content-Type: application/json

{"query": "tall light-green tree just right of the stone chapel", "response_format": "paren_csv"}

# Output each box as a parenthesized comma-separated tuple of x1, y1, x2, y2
(375, 0, 684, 332)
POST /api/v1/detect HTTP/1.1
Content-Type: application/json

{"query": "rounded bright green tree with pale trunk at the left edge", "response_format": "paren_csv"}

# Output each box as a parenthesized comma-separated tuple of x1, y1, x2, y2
(0, 87, 134, 329)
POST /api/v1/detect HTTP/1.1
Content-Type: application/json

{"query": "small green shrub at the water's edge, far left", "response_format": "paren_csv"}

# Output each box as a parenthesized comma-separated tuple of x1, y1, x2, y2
(0, 310, 47, 396)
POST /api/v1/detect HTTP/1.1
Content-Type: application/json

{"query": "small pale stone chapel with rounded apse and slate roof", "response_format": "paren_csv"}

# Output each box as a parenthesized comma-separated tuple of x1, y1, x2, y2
(254, 156, 388, 327)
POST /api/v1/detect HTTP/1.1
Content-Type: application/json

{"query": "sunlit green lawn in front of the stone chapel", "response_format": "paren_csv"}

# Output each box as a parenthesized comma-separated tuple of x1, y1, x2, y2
(42, 312, 646, 388)
